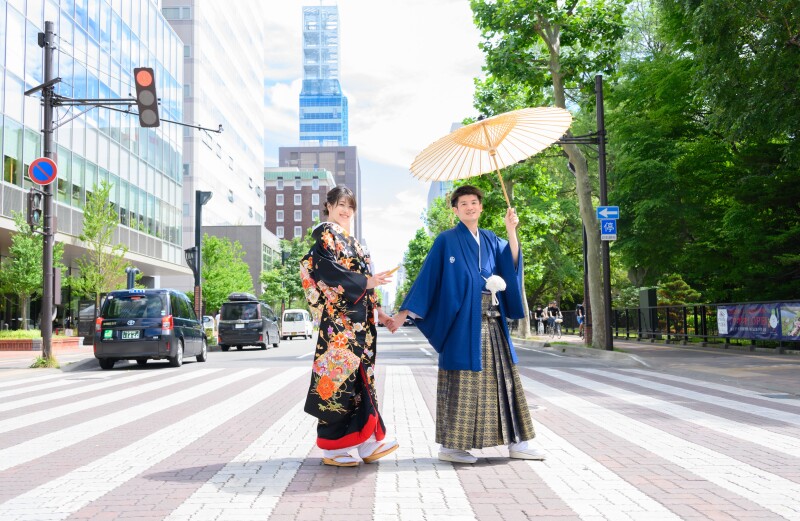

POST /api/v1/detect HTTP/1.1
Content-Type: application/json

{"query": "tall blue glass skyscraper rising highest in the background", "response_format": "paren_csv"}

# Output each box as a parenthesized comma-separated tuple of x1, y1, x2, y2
(300, 5, 348, 146)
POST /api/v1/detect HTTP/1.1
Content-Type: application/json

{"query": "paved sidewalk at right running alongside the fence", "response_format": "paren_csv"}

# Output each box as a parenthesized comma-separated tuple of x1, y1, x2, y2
(514, 335, 800, 396)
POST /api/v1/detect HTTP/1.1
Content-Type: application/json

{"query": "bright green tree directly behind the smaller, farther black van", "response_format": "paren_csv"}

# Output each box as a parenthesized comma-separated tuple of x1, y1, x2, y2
(201, 233, 253, 310)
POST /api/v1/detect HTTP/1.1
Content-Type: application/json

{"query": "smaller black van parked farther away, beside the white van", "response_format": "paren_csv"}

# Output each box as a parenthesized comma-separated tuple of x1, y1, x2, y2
(217, 293, 281, 351)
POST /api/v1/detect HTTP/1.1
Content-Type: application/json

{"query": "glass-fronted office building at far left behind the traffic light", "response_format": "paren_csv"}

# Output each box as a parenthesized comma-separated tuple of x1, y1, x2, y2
(0, 0, 189, 324)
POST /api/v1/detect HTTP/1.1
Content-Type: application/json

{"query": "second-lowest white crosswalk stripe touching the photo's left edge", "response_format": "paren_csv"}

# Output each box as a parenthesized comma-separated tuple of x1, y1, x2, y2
(0, 369, 259, 471)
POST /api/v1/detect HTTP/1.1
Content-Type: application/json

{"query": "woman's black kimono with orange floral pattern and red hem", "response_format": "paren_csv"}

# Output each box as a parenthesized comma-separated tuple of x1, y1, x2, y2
(300, 222, 386, 450)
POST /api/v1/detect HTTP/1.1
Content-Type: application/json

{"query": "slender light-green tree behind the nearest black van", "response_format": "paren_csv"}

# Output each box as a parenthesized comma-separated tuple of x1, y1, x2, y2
(69, 181, 129, 310)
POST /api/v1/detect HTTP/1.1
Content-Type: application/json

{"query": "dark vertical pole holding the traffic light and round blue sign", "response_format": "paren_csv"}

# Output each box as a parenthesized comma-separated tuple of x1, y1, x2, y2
(39, 22, 55, 360)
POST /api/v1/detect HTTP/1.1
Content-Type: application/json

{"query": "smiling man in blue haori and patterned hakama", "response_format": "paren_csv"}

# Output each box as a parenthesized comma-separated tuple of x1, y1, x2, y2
(389, 185, 544, 463)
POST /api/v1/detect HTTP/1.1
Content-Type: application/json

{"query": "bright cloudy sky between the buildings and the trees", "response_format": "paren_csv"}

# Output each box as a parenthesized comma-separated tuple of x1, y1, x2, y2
(265, 0, 483, 295)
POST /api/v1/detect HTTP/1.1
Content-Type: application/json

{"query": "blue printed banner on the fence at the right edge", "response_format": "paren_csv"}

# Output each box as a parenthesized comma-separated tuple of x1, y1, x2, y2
(717, 303, 800, 340)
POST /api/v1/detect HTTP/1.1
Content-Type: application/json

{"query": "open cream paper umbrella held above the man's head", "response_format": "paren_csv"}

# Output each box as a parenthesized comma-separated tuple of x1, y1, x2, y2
(411, 107, 572, 206)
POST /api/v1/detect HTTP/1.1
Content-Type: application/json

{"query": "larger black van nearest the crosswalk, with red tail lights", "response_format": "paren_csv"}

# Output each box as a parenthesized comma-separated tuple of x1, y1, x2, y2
(94, 289, 208, 369)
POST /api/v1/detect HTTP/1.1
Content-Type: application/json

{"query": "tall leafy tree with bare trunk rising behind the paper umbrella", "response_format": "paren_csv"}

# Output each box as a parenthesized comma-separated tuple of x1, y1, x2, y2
(471, 0, 629, 347)
